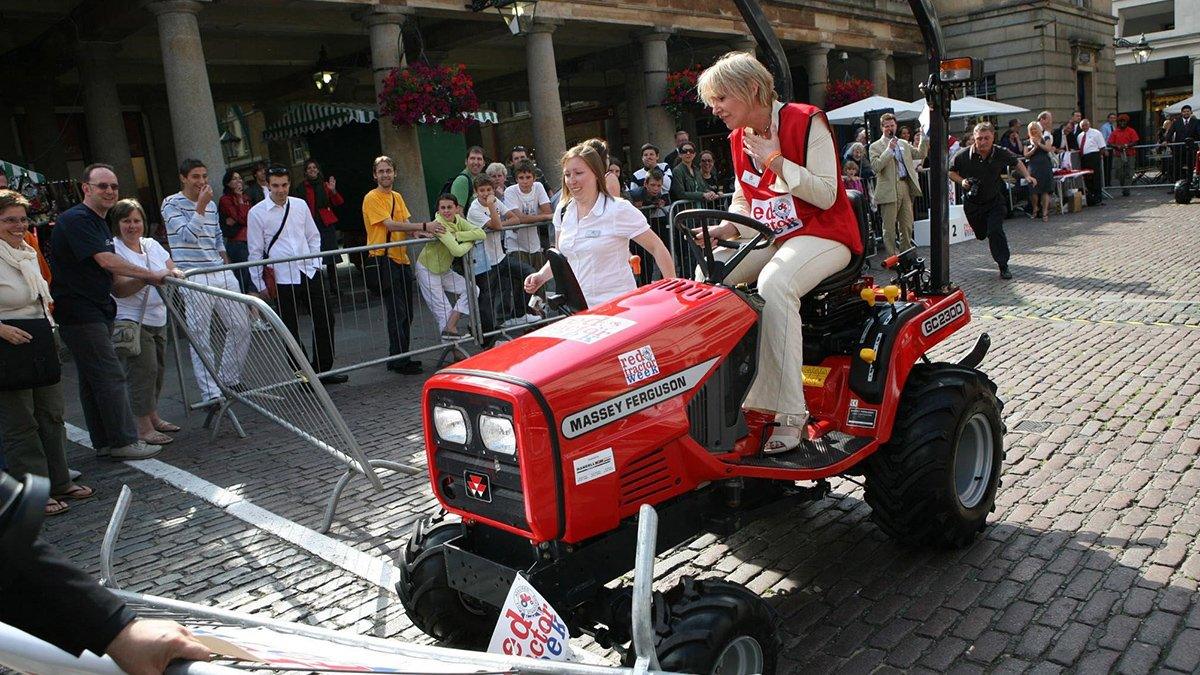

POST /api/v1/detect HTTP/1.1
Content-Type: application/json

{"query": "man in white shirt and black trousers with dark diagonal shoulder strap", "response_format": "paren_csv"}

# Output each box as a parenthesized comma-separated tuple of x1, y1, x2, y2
(246, 167, 349, 384)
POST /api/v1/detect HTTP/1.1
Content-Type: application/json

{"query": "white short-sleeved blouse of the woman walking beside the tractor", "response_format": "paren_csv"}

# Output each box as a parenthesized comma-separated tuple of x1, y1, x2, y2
(554, 195, 650, 307)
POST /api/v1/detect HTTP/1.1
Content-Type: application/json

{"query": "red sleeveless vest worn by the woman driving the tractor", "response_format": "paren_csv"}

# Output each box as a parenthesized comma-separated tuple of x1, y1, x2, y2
(730, 103, 863, 253)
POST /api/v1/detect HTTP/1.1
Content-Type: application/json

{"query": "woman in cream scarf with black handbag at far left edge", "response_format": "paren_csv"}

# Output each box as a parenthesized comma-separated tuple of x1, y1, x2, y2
(0, 190, 96, 515)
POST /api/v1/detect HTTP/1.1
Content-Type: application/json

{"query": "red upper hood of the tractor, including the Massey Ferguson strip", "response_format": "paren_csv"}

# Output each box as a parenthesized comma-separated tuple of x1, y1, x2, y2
(441, 279, 757, 422)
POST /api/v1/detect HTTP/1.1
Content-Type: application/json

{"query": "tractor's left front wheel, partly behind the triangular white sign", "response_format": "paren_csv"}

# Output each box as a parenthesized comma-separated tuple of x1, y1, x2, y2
(396, 514, 500, 650)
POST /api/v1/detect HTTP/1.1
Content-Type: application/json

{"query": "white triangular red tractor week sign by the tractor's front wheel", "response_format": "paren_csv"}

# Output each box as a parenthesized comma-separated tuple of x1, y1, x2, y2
(487, 572, 571, 661)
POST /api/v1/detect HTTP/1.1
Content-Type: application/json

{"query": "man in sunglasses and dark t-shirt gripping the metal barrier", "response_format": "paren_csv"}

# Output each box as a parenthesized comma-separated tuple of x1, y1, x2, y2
(50, 165, 174, 460)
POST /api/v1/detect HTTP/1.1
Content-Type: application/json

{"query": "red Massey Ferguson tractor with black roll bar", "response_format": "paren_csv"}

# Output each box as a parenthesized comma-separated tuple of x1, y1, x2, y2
(397, 0, 1004, 674)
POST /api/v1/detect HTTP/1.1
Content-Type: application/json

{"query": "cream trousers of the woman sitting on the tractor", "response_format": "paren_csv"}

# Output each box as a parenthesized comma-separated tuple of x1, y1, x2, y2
(719, 235, 851, 417)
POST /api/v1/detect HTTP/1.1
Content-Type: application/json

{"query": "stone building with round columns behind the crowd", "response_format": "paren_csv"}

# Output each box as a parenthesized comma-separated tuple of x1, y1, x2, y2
(0, 0, 924, 215)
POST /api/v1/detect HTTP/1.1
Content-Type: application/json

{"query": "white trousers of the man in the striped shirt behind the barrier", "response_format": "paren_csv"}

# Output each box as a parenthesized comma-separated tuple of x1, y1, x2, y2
(181, 271, 250, 400)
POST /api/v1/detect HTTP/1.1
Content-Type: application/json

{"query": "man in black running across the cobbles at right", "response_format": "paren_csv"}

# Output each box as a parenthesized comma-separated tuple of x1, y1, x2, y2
(950, 123, 1038, 279)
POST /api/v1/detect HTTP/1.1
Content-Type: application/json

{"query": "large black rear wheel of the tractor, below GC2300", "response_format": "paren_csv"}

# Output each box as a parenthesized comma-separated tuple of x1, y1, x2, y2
(864, 363, 1004, 548)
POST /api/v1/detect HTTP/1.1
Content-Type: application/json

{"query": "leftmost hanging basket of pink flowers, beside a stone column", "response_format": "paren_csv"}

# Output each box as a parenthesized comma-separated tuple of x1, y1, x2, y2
(379, 61, 479, 133)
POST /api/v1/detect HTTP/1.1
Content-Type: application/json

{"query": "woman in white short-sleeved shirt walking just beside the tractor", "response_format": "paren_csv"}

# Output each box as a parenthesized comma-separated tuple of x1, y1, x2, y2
(524, 144, 676, 307)
